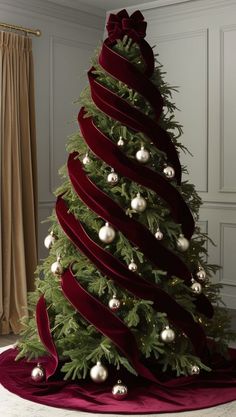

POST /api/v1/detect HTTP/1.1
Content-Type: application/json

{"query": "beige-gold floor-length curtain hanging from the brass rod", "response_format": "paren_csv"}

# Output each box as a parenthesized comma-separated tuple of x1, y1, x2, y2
(0, 32, 37, 334)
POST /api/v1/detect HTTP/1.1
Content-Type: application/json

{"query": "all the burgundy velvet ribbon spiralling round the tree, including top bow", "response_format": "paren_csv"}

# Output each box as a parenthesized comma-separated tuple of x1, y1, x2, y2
(37, 11, 213, 381)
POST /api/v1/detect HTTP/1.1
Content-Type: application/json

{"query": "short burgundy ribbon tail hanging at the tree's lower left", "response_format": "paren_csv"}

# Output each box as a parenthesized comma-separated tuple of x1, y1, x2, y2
(36, 295, 59, 379)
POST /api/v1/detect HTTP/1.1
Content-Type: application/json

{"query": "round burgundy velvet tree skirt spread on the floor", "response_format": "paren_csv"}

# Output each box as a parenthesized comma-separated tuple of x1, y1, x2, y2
(0, 349, 236, 414)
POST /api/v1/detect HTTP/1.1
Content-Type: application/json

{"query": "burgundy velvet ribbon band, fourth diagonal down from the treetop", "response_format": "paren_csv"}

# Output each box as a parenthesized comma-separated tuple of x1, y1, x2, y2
(68, 151, 192, 283)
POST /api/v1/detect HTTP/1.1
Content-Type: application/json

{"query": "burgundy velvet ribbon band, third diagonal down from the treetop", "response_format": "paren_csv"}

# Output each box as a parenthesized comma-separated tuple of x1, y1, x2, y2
(78, 109, 194, 239)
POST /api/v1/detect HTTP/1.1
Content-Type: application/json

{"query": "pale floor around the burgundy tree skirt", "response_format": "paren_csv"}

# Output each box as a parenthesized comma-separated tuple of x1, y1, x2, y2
(0, 335, 236, 417)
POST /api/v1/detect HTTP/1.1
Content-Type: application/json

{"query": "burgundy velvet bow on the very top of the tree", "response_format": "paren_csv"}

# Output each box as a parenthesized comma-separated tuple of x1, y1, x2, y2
(106, 9, 147, 42)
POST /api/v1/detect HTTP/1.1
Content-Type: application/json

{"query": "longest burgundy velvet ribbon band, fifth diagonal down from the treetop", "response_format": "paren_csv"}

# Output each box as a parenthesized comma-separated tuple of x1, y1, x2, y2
(56, 197, 206, 358)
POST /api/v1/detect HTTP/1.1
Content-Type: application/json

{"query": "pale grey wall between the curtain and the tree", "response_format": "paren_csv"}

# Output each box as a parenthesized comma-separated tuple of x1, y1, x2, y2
(0, 0, 105, 258)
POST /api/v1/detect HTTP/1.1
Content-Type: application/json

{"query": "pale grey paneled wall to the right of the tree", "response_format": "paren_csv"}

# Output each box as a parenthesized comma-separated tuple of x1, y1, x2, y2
(114, 0, 236, 308)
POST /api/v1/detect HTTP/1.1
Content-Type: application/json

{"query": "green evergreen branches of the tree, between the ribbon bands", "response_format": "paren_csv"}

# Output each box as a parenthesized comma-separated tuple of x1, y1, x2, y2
(18, 36, 233, 379)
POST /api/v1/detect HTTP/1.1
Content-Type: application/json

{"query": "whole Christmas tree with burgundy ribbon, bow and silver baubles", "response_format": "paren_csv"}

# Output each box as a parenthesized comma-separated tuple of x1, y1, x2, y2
(18, 10, 232, 382)
